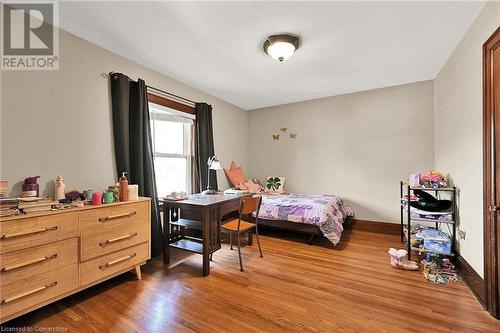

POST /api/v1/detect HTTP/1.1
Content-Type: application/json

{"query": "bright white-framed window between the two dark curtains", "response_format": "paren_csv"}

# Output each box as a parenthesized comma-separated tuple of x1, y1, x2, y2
(149, 98, 194, 198)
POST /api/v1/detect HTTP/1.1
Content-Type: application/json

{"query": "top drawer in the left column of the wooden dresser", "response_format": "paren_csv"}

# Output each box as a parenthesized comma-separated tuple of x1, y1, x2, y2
(0, 212, 78, 254)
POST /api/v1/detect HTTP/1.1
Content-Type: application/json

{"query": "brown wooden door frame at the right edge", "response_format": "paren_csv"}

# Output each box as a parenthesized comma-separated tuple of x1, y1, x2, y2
(483, 28, 500, 318)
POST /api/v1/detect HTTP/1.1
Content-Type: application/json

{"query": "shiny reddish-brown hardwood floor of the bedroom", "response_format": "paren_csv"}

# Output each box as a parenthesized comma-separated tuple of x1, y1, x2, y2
(1, 230, 500, 332)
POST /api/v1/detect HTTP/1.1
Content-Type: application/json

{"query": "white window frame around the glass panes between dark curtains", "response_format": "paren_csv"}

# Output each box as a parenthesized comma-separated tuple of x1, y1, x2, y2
(148, 102, 195, 194)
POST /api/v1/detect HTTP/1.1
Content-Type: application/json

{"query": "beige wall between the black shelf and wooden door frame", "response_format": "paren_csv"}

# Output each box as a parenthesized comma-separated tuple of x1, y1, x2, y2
(435, 2, 500, 276)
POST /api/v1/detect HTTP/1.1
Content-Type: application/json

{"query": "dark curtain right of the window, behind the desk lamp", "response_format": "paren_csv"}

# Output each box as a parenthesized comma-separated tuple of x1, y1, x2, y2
(194, 103, 218, 191)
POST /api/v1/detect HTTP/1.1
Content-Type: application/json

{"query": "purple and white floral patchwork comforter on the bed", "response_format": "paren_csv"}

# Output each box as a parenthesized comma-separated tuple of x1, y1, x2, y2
(259, 193, 354, 245)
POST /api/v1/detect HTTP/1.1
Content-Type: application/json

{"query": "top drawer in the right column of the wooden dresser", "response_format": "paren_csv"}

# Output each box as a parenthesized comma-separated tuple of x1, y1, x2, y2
(80, 201, 150, 233)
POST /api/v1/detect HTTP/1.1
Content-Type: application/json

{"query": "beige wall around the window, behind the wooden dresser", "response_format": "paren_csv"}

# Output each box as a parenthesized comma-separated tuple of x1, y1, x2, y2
(0, 31, 248, 194)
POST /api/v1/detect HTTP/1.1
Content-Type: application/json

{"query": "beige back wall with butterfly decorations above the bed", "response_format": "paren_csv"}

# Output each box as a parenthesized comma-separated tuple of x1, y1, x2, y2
(247, 81, 434, 222)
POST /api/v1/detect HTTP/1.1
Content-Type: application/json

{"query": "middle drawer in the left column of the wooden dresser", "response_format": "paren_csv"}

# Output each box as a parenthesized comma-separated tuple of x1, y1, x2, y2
(0, 237, 78, 287)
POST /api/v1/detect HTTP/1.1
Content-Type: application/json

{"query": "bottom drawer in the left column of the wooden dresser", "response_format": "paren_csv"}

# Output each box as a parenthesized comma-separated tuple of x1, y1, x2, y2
(0, 264, 78, 321)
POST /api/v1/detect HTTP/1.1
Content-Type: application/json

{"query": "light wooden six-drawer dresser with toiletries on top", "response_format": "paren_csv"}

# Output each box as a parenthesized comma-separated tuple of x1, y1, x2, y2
(0, 198, 151, 323)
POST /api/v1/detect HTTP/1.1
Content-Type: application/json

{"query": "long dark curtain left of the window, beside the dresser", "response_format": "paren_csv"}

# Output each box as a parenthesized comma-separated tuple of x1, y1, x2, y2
(110, 73, 163, 256)
